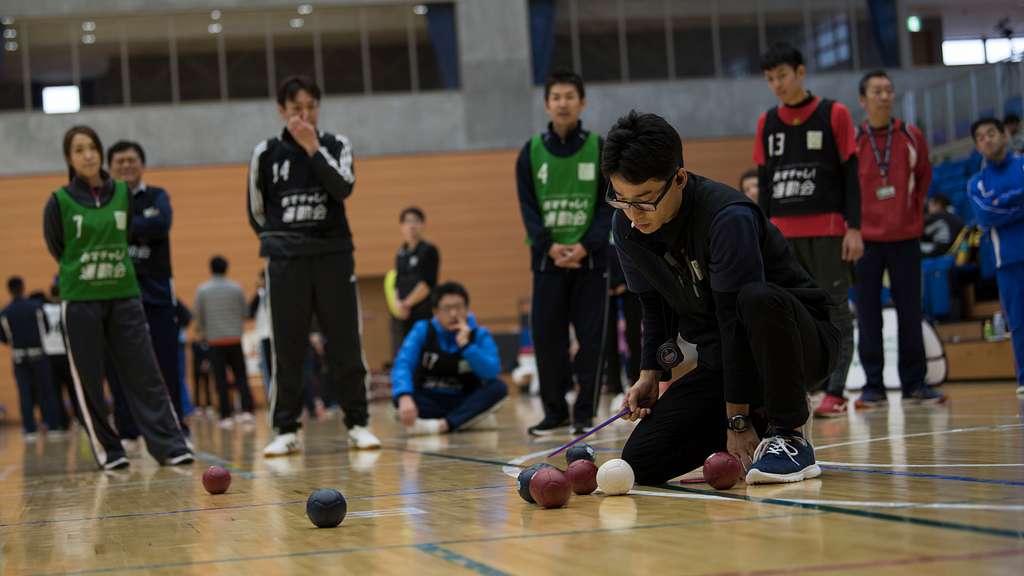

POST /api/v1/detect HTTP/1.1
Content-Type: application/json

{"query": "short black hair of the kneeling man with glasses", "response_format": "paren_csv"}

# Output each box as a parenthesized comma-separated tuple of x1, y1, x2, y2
(601, 110, 683, 184)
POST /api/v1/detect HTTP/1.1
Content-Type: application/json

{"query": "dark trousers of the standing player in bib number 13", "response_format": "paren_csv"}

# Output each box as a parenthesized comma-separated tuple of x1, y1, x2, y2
(788, 236, 851, 396)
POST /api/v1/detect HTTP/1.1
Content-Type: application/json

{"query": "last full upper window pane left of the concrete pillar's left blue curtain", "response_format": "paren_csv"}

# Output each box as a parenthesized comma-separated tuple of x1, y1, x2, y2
(364, 5, 413, 92)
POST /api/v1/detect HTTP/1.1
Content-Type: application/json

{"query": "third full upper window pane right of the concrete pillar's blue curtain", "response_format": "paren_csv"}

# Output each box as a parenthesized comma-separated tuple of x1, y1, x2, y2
(669, 0, 715, 78)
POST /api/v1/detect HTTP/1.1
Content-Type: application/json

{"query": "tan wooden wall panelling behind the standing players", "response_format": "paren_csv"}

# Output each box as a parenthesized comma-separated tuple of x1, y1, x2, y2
(0, 138, 752, 419)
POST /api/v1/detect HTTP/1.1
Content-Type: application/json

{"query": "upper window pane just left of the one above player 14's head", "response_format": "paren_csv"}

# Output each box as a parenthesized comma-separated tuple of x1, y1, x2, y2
(221, 11, 273, 99)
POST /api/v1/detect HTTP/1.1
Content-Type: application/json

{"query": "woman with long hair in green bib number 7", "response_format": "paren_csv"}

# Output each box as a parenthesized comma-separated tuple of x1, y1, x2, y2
(43, 126, 194, 469)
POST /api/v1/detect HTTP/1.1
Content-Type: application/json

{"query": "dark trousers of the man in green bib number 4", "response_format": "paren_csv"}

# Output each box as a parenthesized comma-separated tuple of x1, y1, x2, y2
(530, 269, 608, 425)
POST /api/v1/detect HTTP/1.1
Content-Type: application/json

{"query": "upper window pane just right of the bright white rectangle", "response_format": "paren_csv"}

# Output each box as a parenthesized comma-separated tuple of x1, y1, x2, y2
(75, 18, 124, 107)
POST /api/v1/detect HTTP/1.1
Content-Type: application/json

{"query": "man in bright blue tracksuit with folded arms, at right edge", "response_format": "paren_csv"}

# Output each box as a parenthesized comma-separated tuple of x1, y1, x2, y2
(968, 118, 1024, 394)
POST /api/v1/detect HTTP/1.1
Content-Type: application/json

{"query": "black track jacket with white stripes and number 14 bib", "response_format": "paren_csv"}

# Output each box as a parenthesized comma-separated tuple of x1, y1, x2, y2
(248, 128, 355, 258)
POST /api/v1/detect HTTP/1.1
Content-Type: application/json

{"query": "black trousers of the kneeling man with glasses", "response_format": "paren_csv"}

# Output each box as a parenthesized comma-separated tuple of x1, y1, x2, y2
(623, 284, 840, 485)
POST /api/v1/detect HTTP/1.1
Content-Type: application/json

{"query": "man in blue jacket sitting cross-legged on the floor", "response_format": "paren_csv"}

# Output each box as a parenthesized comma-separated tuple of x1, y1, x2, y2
(391, 282, 508, 436)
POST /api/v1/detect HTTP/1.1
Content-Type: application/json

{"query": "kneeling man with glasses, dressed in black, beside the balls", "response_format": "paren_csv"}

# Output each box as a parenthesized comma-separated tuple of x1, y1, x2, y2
(601, 112, 840, 485)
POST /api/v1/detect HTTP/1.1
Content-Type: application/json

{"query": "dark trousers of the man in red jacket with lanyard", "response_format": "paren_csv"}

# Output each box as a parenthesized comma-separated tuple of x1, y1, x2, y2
(854, 239, 928, 395)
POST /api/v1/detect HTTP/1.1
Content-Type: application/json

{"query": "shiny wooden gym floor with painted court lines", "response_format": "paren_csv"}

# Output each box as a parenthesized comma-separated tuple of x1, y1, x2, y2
(0, 382, 1024, 576)
